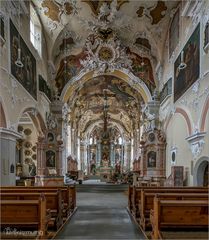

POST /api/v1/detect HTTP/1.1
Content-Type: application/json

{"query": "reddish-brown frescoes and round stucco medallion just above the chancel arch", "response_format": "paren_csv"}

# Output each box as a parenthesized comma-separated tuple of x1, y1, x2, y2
(55, 42, 156, 94)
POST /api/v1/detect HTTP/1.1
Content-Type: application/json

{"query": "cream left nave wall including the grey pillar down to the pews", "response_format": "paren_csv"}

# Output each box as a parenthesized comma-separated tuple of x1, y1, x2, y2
(0, 1, 50, 185)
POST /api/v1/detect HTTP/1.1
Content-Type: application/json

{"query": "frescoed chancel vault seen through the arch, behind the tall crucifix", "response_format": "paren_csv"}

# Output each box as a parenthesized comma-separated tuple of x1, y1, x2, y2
(68, 76, 143, 137)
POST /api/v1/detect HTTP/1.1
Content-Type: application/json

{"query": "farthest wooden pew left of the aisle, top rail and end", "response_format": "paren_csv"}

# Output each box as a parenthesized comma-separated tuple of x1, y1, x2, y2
(0, 185, 76, 219)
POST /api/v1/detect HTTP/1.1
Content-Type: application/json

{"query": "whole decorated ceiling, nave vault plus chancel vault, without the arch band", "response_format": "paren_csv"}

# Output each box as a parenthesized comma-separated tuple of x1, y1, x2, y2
(33, 0, 179, 137)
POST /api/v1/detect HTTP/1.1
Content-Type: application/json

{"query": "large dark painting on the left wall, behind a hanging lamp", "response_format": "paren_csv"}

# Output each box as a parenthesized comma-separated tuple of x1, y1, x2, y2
(10, 19, 37, 100)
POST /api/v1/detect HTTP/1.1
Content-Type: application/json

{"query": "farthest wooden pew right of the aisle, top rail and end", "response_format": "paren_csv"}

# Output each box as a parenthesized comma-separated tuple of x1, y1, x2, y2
(131, 187, 208, 221)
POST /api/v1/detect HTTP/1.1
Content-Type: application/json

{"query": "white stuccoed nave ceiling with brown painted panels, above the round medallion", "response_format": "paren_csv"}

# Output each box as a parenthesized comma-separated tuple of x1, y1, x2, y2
(33, 0, 179, 69)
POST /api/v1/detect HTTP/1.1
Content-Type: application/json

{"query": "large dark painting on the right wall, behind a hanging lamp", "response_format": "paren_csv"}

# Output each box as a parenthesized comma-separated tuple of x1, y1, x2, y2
(174, 24, 200, 102)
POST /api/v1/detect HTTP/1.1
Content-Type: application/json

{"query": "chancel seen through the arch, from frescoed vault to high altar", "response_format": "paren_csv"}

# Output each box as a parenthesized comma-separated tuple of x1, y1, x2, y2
(62, 75, 145, 179)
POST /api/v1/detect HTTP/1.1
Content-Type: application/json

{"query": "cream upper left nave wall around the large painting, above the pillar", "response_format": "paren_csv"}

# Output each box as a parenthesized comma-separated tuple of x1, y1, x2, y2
(0, 1, 49, 129)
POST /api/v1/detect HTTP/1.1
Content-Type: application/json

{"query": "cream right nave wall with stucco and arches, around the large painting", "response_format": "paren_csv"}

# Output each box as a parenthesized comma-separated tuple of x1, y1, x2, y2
(160, 1, 209, 185)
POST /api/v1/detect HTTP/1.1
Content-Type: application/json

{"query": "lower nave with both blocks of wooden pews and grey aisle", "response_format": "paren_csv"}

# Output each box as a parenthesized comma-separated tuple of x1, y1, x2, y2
(0, 180, 209, 240)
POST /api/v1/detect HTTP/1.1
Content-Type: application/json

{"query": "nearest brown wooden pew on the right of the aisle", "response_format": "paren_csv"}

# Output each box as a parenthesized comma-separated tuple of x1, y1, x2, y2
(150, 197, 208, 239)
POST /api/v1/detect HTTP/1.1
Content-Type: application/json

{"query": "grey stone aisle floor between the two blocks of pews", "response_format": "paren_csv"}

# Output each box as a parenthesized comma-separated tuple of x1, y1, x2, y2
(56, 188, 145, 240)
